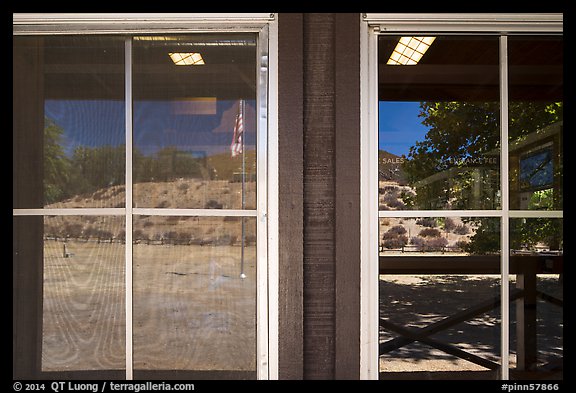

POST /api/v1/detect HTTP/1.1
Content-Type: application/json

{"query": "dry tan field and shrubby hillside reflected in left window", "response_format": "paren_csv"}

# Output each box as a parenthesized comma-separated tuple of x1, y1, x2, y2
(42, 179, 256, 371)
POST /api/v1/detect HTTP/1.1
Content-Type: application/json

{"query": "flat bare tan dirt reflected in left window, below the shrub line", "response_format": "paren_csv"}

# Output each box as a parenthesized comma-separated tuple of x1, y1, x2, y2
(42, 241, 256, 371)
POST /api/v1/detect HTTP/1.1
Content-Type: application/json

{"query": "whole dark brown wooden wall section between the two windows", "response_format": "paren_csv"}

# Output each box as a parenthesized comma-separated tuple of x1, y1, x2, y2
(278, 13, 360, 379)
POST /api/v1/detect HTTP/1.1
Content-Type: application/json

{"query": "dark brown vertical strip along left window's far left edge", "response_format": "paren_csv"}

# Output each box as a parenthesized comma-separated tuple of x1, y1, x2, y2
(12, 37, 44, 379)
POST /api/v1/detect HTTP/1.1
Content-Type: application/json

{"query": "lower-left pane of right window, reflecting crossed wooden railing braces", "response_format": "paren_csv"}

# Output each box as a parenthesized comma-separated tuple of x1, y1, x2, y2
(379, 217, 501, 379)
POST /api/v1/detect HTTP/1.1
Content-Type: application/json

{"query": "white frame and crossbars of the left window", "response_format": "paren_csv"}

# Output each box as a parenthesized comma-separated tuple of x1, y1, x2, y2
(13, 13, 279, 380)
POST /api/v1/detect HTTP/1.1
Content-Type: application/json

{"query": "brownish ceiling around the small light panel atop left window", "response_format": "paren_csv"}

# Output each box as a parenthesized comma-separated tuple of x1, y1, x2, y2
(43, 35, 256, 100)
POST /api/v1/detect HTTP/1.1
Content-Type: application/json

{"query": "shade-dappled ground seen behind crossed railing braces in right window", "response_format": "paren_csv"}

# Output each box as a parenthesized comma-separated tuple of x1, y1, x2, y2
(380, 275, 562, 379)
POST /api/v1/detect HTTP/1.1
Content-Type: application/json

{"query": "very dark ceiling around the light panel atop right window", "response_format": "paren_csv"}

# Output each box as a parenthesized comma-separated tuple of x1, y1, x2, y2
(378, 36, 563, 101)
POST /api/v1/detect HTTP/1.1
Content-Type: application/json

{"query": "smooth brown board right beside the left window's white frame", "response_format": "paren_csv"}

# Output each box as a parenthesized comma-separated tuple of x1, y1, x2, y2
(278, 13, 304, 380)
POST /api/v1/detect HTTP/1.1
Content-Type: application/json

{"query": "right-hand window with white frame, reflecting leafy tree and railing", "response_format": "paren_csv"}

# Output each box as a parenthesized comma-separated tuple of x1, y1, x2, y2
(361, 14, 563, 379)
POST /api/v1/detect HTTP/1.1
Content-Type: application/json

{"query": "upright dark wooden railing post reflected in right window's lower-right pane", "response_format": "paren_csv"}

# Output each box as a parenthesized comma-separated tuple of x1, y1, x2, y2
(516, 258, 537, 371)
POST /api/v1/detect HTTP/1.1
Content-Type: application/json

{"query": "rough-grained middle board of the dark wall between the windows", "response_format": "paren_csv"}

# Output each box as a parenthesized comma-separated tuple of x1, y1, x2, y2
(303, 14, 335, 379)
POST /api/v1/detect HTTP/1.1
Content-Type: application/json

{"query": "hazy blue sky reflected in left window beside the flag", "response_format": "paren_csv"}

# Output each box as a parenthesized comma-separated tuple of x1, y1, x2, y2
(44, 100, 256, 157)
